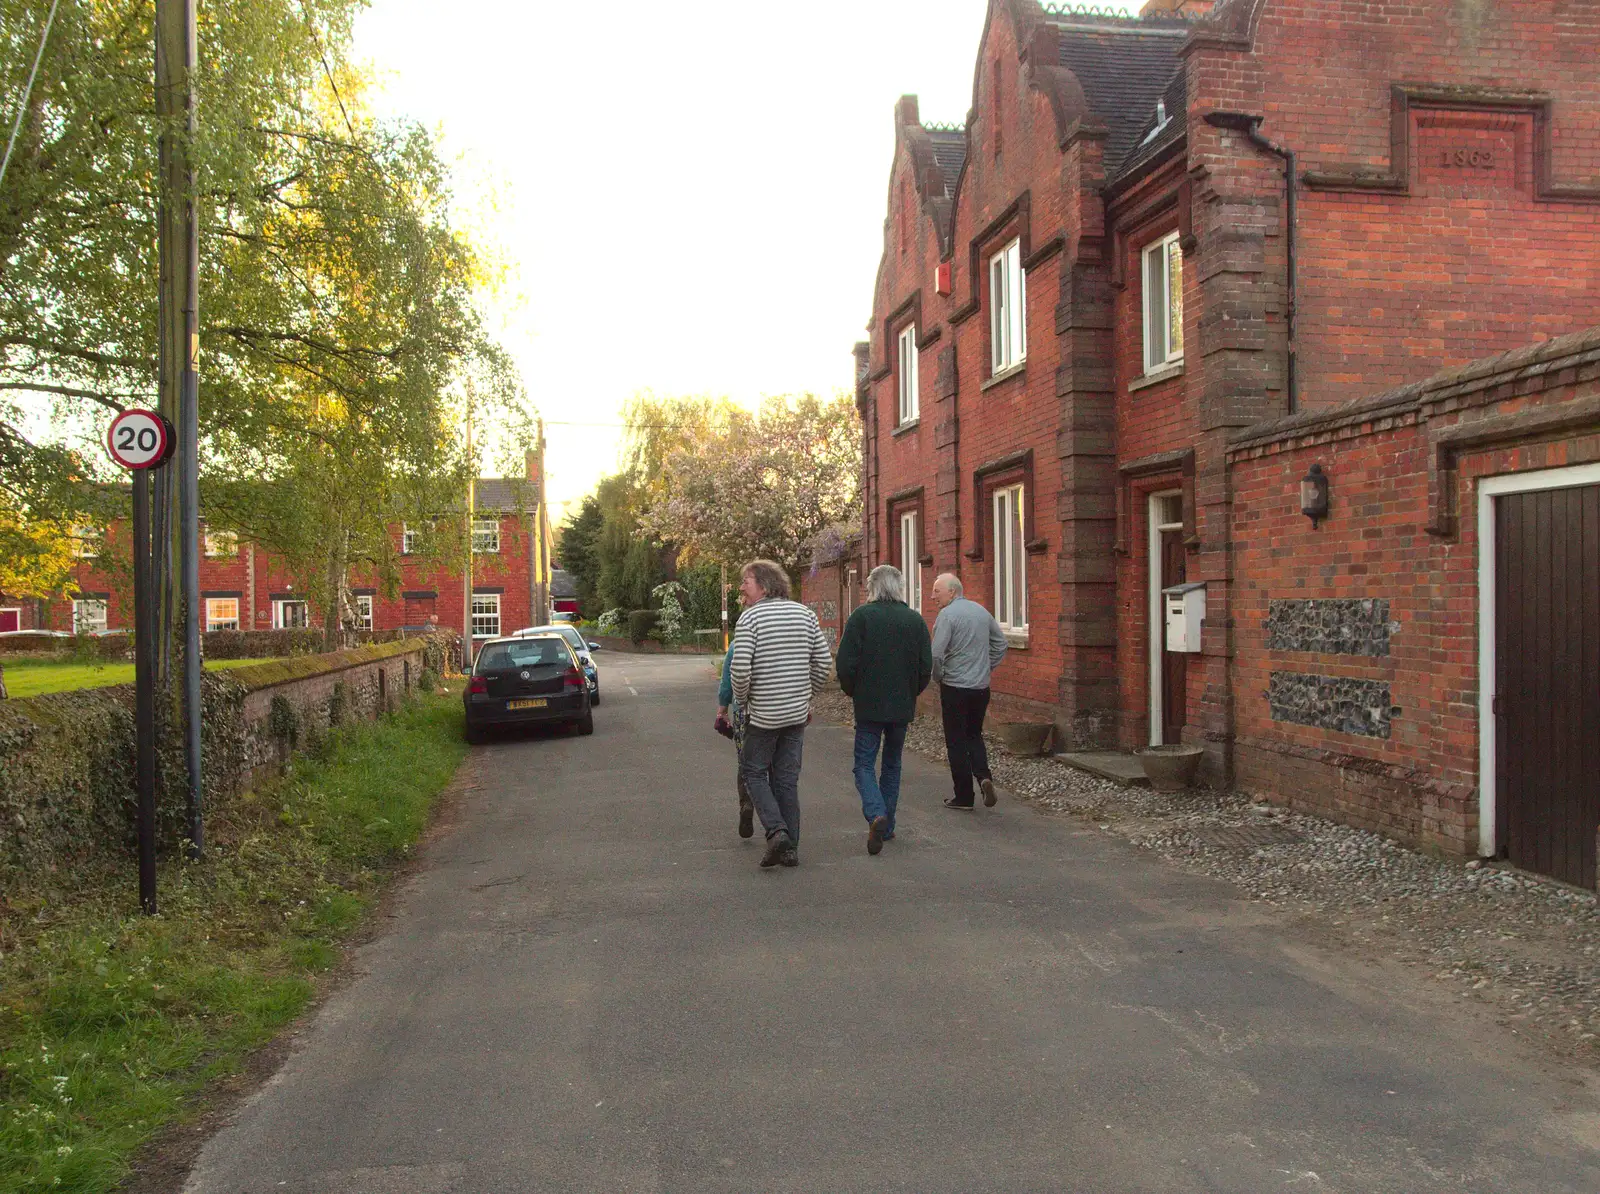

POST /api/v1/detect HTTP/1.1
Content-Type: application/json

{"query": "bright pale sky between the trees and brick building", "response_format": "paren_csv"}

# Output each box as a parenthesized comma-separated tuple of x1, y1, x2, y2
(355, 0, 1024, 517)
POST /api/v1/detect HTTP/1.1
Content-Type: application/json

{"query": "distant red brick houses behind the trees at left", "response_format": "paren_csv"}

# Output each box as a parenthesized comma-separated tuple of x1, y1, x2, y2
(0, 448, 550, 656)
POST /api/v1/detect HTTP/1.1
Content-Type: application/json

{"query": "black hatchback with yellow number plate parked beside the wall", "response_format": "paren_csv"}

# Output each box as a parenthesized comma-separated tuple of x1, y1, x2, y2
(461, 634, 595, 743)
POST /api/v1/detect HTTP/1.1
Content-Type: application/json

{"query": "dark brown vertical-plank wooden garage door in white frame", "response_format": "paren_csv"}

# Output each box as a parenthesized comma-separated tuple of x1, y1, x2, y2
(1494, 485, 1600, 888)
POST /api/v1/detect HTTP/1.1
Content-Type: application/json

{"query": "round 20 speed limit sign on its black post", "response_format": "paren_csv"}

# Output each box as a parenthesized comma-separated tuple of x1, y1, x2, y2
(106, 410, 178, 914)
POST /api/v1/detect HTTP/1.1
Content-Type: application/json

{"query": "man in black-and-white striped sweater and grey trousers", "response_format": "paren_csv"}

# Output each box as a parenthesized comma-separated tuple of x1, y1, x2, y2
(728, 560, 832, 866)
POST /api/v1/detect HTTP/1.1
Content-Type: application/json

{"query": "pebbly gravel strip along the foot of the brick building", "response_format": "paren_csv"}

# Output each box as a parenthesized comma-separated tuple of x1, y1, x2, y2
(818, 691, 1600, 1063)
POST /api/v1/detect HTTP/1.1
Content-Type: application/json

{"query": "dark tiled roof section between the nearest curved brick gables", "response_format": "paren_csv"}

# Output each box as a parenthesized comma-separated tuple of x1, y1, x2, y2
(1056, 14, 1190, 178)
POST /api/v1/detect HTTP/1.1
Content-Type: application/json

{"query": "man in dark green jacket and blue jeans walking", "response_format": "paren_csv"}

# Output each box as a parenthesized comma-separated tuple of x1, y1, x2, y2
(834, 563, 933, 855)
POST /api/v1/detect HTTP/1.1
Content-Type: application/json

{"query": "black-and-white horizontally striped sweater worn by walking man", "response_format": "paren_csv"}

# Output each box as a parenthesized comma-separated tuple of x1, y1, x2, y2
(728, 597, 832, 730)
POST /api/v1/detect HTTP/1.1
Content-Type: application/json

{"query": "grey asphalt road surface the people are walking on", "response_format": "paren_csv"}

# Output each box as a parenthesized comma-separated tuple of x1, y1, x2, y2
(187, 655, 1600, 1194)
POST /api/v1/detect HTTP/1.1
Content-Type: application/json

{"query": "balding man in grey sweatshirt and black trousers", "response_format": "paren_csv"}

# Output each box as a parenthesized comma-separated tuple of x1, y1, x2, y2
(933, 573, 1006, 808)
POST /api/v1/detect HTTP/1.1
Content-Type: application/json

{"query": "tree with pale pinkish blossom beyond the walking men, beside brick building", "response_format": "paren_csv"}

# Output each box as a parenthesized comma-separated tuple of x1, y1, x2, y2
(640, 394, 861, 578)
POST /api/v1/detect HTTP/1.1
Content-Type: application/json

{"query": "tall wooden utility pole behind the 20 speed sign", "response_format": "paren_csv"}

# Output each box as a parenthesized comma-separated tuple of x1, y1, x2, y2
(155, 0, 205, 858)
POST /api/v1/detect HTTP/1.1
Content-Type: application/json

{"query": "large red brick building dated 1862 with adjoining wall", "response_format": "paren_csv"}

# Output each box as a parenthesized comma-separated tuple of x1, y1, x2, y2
(856, 0, 1600, 882)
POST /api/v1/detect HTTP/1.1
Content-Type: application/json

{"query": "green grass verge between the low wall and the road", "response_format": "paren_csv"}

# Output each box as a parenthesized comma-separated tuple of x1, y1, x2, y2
(0, 685, 466, 1194)
